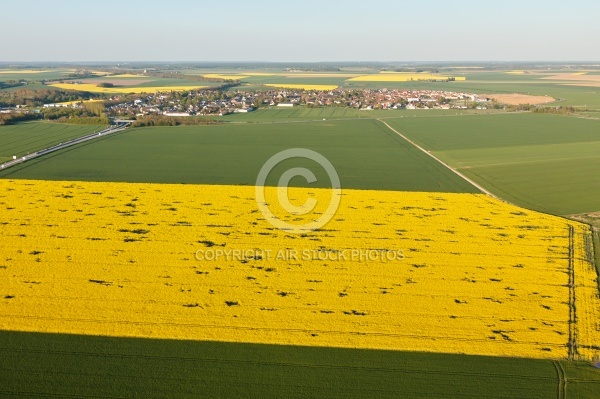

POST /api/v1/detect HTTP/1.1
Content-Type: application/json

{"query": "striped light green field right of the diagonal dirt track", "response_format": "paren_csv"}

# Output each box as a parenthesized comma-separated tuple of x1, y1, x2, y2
(388, 113, 600, 215)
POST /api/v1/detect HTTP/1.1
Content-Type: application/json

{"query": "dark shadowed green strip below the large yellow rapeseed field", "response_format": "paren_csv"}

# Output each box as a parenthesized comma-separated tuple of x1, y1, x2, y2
(0, 331, 600, 399)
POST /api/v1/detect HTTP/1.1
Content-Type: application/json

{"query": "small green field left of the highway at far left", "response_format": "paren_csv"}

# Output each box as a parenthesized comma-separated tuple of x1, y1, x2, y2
(0, 122, 104, 163)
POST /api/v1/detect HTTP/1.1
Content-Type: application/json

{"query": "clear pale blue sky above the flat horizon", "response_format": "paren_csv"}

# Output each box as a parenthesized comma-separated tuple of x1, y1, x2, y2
(0, 0, 600, 61)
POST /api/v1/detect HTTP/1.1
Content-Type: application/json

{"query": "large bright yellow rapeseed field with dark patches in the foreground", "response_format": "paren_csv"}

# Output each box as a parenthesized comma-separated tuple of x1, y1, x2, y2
(0, 179, 600, 359)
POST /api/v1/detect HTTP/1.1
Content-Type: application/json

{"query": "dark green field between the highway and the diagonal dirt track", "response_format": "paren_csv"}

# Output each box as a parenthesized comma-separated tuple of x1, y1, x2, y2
(2, 119, 475, 192)
